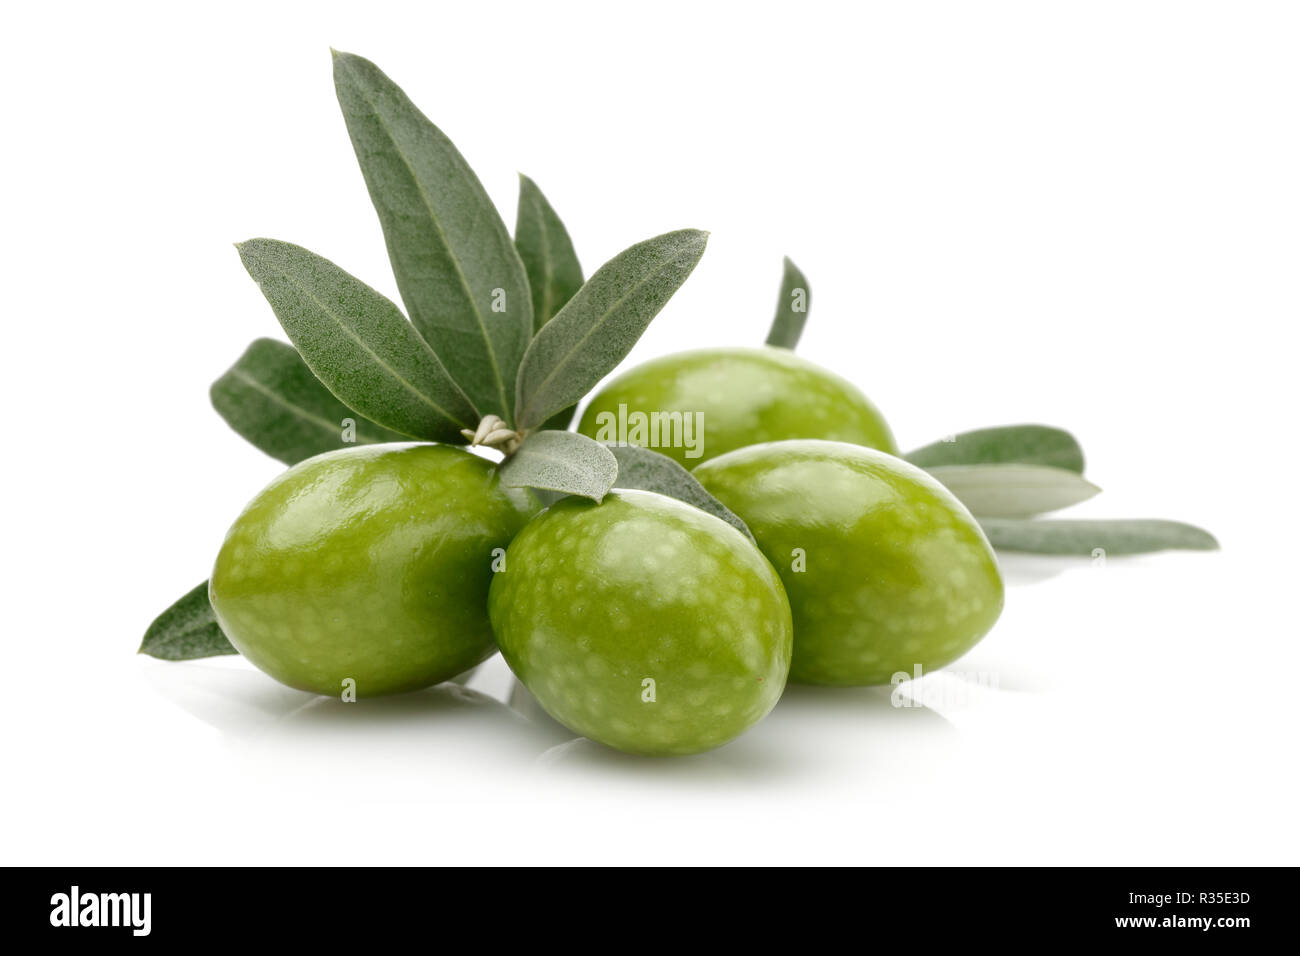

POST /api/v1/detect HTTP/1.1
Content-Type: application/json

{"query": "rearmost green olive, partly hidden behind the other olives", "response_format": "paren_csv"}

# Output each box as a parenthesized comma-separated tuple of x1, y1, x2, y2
(577, 347, 898, 468)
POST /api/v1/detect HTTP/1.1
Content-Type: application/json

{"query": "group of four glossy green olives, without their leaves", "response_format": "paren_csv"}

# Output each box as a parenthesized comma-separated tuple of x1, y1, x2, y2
(209, 347, 1002, 754)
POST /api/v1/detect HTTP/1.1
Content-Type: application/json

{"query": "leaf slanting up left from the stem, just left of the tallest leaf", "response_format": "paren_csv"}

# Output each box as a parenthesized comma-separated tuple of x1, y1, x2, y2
(238, 239, 478, 441)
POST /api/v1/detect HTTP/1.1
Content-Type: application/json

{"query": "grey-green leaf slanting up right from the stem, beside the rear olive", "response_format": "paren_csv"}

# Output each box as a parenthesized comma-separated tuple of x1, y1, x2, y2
(515, 229, 709, 429)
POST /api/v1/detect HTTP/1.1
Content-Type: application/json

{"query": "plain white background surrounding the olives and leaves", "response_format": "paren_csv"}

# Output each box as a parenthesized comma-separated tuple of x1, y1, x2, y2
(0, 0, 1300, 865)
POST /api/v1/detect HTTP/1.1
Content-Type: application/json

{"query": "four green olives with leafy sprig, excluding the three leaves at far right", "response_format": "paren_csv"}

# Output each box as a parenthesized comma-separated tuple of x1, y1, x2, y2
(157, 51, 1002, 754)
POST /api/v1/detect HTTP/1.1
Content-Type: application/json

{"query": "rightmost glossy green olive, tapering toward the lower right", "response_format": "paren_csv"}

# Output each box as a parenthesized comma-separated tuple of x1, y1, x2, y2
(694, 441, 1002, 684)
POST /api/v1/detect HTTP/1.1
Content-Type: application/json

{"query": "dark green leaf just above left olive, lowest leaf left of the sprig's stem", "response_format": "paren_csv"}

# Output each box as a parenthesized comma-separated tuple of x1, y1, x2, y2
(211, 338, 406, 464)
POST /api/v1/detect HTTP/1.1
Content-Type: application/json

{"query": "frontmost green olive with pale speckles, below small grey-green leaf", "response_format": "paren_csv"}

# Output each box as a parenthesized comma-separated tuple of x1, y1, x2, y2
(489, 490, 792, 754)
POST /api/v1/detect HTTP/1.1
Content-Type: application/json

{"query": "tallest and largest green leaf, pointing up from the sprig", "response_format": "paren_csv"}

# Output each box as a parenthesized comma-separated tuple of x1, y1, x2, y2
(334, 51, 533, 421)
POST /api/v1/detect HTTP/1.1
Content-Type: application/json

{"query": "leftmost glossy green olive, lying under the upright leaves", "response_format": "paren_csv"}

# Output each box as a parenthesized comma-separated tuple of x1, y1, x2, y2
(208, 444, 540, 697)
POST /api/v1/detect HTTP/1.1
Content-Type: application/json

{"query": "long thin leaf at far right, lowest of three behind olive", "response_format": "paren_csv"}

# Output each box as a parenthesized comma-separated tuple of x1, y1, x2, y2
(980, 518, 1219, 557)
